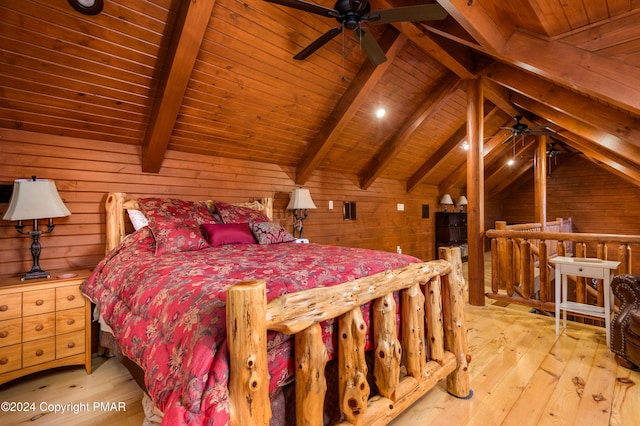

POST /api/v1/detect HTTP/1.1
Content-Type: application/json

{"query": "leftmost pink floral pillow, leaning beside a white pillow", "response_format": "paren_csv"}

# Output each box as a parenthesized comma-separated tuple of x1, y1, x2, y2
(139, 198, 216, 256)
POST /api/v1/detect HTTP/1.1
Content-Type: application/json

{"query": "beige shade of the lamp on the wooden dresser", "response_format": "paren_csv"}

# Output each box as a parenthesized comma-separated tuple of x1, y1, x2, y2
(3, 179, 71, 220)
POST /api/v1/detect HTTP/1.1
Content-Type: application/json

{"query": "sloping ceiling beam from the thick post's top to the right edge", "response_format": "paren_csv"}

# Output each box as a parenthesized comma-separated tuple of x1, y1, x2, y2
(482, 63, 640, 150)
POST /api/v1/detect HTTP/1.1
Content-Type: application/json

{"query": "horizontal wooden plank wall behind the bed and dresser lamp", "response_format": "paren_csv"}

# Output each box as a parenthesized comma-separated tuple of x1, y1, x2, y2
(0, 129, 438, 276)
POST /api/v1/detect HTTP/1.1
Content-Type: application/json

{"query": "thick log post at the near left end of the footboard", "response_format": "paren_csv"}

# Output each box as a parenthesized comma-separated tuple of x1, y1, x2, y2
(227, 280, 271, 426)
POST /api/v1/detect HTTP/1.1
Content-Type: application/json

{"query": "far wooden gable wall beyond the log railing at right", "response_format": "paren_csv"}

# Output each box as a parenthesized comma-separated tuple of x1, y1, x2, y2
(500, 155, 640, 267)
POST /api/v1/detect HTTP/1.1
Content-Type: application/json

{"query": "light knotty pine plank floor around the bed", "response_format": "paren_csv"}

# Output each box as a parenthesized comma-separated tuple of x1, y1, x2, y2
(0, 255, 640, 426)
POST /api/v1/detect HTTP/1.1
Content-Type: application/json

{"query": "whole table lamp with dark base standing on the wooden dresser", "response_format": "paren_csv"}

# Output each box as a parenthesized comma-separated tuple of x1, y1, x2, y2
(3, 176, 71, 281)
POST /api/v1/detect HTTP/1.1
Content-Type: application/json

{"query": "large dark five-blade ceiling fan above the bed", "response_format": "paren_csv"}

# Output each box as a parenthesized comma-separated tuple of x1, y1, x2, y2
(266, 0, 447, 65)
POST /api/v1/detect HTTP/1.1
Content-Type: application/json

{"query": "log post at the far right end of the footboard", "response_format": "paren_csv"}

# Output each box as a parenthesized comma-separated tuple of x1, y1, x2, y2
(439, 247, 471, 398)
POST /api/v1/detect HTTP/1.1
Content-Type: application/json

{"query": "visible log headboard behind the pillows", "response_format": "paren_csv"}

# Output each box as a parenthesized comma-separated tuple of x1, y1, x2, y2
(104, 192, 273, 253)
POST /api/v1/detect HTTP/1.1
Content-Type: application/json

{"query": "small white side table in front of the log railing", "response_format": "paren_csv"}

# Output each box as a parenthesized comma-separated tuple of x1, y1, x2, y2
(549, 256, 620, 346)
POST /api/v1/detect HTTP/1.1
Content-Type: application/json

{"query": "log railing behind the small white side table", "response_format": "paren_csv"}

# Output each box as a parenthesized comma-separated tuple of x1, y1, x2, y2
(485, 222, 640, 312)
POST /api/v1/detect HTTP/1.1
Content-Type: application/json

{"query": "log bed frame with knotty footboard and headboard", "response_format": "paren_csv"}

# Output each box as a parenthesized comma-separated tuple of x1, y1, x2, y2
(105, 193, 473, 426)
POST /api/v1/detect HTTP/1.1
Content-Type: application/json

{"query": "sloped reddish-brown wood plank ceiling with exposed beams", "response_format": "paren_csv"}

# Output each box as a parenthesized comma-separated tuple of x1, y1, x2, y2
(0, 0, 640, 194)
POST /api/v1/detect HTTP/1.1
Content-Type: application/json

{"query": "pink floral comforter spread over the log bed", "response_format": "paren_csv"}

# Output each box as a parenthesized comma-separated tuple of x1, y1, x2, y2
(82, 228, 419, 425)
